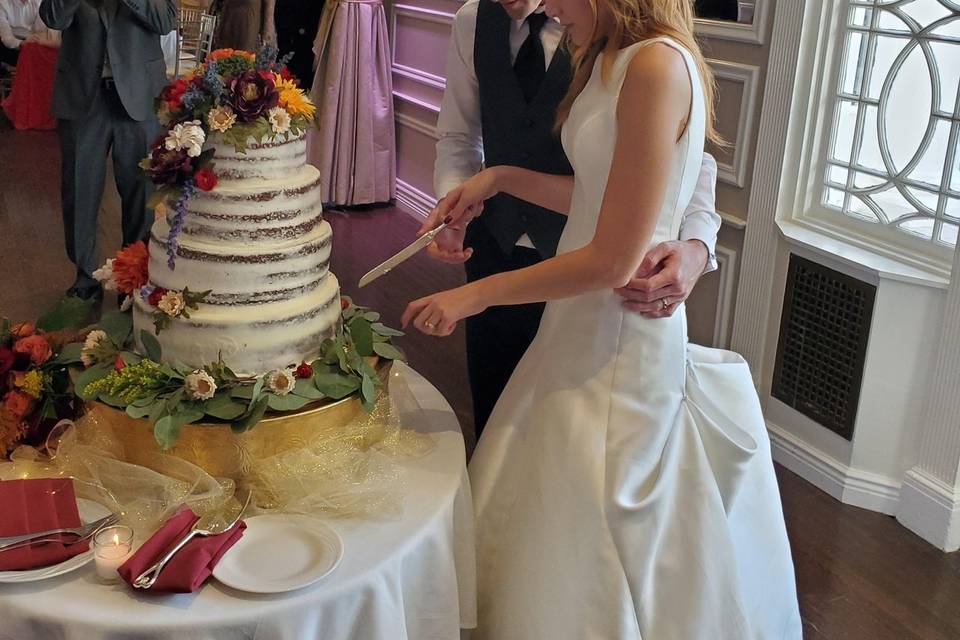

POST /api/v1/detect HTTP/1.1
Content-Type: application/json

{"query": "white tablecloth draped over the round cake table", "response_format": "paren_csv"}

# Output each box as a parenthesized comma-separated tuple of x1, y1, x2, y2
(0, 363, 476, 640)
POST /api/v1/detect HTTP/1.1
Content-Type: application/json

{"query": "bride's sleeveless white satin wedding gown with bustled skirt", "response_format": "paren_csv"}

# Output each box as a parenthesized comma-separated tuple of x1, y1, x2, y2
(470, 39, 801, 640)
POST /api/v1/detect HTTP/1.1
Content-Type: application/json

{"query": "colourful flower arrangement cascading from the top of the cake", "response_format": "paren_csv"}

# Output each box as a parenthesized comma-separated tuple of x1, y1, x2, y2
(141, 46, 316, 269)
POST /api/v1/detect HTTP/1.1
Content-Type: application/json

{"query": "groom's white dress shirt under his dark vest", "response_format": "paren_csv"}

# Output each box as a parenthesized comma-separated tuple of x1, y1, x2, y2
(433, 0, 721, 271)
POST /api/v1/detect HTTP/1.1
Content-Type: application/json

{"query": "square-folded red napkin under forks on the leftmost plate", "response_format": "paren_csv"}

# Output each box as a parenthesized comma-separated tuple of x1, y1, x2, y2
(0, 478, 90, 571)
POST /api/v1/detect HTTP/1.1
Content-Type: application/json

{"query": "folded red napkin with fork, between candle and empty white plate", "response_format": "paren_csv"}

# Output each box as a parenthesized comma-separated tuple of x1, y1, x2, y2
(117, 505, 247, 593)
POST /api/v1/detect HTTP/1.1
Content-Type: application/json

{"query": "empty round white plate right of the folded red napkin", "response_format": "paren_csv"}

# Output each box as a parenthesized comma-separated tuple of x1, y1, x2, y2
(213, 514, 343, 593)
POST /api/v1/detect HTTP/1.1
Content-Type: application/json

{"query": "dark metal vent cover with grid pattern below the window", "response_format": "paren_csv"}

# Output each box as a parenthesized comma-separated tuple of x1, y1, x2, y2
(771, 254, 877, 440)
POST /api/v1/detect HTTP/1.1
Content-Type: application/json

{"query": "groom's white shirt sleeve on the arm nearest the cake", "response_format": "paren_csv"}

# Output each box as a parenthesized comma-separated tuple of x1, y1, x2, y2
(433, 1, 483, 198)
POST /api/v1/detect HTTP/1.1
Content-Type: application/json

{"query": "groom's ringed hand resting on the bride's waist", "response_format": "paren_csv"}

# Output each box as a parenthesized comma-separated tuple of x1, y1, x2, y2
(616, 240, 709, 318)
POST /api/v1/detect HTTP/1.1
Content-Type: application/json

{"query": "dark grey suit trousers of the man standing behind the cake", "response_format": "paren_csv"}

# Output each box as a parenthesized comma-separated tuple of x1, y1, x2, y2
(57, 80, 156, 286)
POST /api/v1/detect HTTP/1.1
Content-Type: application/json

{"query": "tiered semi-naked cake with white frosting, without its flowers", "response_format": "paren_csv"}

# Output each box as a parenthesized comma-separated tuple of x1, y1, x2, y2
(133, 134, 340, 375)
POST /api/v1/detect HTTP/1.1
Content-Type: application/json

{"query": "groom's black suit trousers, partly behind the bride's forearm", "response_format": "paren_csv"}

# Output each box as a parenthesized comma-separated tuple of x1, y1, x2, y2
(465, 219, 546, 439)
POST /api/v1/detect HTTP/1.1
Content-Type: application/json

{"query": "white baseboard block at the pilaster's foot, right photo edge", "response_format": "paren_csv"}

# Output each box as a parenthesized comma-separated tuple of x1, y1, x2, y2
(897, 468, 960, 552)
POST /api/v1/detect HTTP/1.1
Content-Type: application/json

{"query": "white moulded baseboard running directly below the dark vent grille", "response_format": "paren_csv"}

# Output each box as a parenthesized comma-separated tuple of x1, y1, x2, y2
(767, 421, 901, 515)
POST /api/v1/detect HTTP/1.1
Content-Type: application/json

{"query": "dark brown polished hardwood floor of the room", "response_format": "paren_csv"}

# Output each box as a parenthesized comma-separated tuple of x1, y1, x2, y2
(0, 124, 960, 640)
